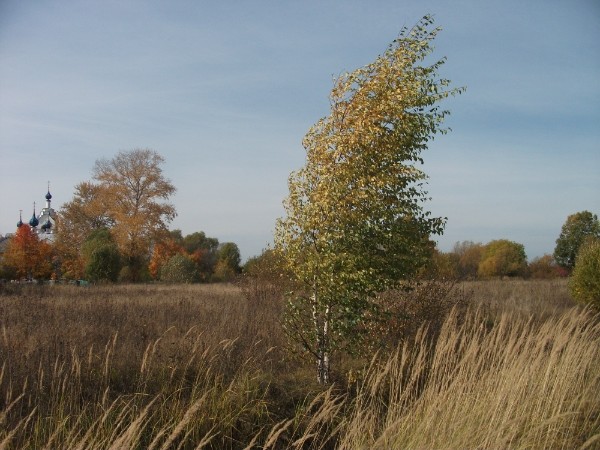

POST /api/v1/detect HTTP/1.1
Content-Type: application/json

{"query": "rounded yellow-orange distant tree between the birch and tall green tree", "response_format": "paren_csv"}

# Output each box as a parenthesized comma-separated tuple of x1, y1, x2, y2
(477, 239, 527, 278)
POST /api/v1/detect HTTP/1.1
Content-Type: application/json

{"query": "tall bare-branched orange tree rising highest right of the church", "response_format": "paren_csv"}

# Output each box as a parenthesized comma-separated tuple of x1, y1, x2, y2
(60, 149, 176, 281)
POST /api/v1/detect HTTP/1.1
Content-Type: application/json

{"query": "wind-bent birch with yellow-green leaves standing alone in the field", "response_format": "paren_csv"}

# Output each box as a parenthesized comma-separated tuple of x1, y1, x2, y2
(275, 17, 461, 383)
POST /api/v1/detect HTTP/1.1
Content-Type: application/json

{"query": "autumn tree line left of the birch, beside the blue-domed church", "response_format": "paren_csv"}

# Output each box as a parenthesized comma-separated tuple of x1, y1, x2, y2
(0, 149, 241, 282)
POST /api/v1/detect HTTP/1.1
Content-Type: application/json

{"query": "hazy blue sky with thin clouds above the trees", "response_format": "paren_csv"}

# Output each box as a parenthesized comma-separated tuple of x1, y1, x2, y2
(0, 0, 600, 260)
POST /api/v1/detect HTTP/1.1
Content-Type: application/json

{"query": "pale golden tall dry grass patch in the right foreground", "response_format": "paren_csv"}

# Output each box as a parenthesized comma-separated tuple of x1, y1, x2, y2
(332, 310, 600, 449)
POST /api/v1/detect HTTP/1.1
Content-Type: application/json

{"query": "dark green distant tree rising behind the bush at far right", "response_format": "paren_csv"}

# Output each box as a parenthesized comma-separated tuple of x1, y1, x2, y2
(554, 211, 600, 270)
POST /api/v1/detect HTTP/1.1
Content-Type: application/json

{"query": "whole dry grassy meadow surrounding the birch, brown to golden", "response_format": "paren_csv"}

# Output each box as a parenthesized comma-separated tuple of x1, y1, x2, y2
(0, 280, 600, 449)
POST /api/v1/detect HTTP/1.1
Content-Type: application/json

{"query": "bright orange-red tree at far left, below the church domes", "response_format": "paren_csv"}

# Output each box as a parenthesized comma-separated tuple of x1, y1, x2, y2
(3, 223, 53, 280)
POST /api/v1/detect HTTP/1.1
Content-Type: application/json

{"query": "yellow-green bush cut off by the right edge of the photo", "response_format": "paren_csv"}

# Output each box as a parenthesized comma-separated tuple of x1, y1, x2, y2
(569, 239, 600, 310)
